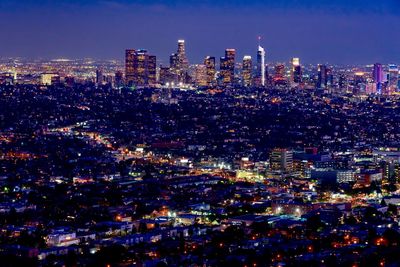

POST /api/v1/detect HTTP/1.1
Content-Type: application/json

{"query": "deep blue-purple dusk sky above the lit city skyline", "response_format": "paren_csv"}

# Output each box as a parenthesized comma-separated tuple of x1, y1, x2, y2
(0, 0, 400, 64)
